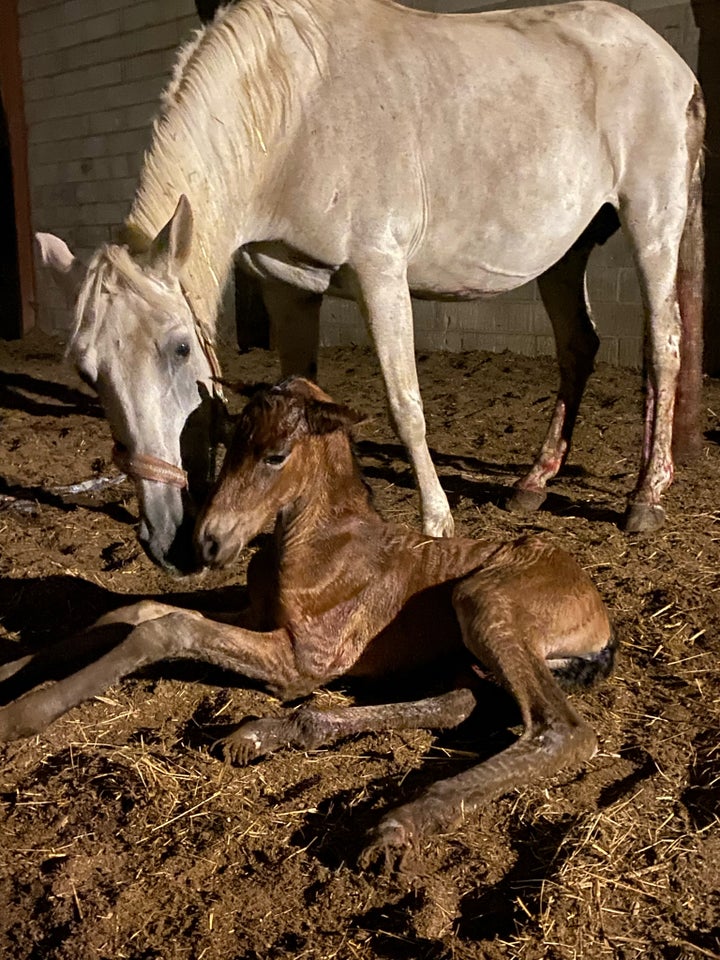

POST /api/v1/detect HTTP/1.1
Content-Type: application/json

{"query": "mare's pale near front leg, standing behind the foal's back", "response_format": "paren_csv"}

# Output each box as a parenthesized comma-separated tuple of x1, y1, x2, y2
(353, 251, 455, 537)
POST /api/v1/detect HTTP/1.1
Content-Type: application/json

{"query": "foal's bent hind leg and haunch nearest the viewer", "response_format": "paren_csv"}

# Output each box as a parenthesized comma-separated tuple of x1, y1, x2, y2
(365, 542, 610, 861)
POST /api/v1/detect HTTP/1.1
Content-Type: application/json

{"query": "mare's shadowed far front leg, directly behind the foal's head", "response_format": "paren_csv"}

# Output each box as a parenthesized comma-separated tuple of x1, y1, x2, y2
(262, 280, 322, 380)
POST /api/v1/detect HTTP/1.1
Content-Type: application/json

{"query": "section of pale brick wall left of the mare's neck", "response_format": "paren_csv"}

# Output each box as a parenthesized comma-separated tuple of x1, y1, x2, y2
(18, 0, 198, 330)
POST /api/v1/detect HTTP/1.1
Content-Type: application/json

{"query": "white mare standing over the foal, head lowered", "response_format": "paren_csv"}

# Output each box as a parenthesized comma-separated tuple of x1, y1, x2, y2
(35, 0, 704, 569)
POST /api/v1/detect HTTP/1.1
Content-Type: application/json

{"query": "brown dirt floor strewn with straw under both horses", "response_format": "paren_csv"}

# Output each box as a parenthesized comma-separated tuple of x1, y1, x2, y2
(0, 336, 720, 960)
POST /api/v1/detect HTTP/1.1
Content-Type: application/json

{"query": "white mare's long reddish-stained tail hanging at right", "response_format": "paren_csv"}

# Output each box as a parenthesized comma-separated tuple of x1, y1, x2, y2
(673, 86, 705, 462)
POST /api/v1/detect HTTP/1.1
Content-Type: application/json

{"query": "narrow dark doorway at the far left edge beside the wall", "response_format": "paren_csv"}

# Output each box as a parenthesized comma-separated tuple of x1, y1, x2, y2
(0, 88, 23, 340)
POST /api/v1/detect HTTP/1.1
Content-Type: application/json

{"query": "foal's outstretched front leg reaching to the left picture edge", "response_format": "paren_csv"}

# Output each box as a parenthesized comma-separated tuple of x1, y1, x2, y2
(0, 601, 306, 741)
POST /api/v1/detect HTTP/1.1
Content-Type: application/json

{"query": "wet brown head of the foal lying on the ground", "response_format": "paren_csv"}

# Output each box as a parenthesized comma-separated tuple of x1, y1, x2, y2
(195, 377, 363, 566)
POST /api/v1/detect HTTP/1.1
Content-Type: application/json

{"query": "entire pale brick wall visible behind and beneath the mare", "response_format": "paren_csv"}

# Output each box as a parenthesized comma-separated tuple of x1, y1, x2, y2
(18, 0, 697, 365)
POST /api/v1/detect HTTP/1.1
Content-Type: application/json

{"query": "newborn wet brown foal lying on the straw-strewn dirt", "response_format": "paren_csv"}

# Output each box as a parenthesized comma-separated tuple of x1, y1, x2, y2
(0, 378, 614, 855)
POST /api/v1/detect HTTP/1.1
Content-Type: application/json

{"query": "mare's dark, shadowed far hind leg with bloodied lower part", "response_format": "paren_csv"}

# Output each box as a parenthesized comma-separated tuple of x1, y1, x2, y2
(507, 235, 599, 512)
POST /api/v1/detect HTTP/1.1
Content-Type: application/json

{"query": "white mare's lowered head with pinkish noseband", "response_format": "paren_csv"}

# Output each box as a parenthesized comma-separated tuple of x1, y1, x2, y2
(37, 197, 222, 573)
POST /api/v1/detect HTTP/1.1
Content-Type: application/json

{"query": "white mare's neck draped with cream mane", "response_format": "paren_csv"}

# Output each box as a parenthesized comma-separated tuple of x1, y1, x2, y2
(126, 0, 330, 333)
